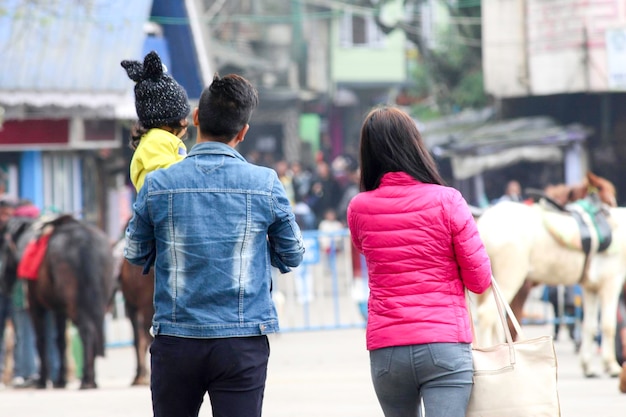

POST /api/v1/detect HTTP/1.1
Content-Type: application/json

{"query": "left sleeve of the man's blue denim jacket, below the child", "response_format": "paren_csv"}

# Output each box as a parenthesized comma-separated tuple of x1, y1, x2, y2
(124, 187, 156, 274)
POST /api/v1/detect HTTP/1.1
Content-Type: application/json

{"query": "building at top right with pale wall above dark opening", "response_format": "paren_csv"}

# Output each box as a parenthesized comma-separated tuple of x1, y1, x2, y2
(482, 0, 626, 204)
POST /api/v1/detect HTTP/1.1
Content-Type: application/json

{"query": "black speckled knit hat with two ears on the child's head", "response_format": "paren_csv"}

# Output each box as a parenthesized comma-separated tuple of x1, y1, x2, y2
(121, 51, 191, 129)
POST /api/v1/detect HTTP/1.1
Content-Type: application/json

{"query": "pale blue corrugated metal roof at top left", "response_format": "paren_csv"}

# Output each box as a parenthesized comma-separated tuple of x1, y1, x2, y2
(0, 0, 152, 107)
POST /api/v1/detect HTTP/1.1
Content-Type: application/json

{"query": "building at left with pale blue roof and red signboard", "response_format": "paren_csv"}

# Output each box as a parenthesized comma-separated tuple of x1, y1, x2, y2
(0, 0, 156, 234)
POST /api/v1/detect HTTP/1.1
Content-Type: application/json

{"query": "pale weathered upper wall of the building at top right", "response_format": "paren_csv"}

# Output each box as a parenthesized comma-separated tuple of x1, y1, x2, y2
(483, 0, 626, 97)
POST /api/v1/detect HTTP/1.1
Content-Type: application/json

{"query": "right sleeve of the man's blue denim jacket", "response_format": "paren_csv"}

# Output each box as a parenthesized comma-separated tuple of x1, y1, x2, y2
(268, 172, 304, 274)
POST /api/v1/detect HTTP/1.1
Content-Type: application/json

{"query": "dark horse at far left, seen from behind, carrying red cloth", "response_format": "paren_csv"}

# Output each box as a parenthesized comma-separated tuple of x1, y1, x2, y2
(9, 215, 115, 389)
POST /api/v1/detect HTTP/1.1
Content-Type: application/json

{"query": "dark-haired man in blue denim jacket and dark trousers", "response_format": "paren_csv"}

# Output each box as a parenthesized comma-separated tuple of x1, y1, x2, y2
(124, 74, 304, 417)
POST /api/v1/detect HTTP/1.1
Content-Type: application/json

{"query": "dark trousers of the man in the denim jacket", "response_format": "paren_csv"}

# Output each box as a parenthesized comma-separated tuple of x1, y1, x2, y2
(150, 336, 270, 417)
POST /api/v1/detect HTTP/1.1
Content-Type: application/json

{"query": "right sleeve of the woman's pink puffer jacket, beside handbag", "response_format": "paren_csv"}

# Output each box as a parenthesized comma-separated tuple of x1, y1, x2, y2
(450, 192, 491, 294)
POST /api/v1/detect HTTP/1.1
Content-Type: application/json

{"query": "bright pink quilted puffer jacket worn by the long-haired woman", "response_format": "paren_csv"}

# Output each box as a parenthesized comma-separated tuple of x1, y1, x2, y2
(348, 172, 491, 350)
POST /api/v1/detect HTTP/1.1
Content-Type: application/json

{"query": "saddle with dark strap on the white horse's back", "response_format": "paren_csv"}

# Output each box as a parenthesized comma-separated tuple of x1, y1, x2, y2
(542, 196, 615, 255)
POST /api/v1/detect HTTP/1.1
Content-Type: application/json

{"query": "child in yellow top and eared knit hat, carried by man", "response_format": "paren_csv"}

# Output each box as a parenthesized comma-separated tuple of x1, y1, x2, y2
(121, 51, 191, 191)
